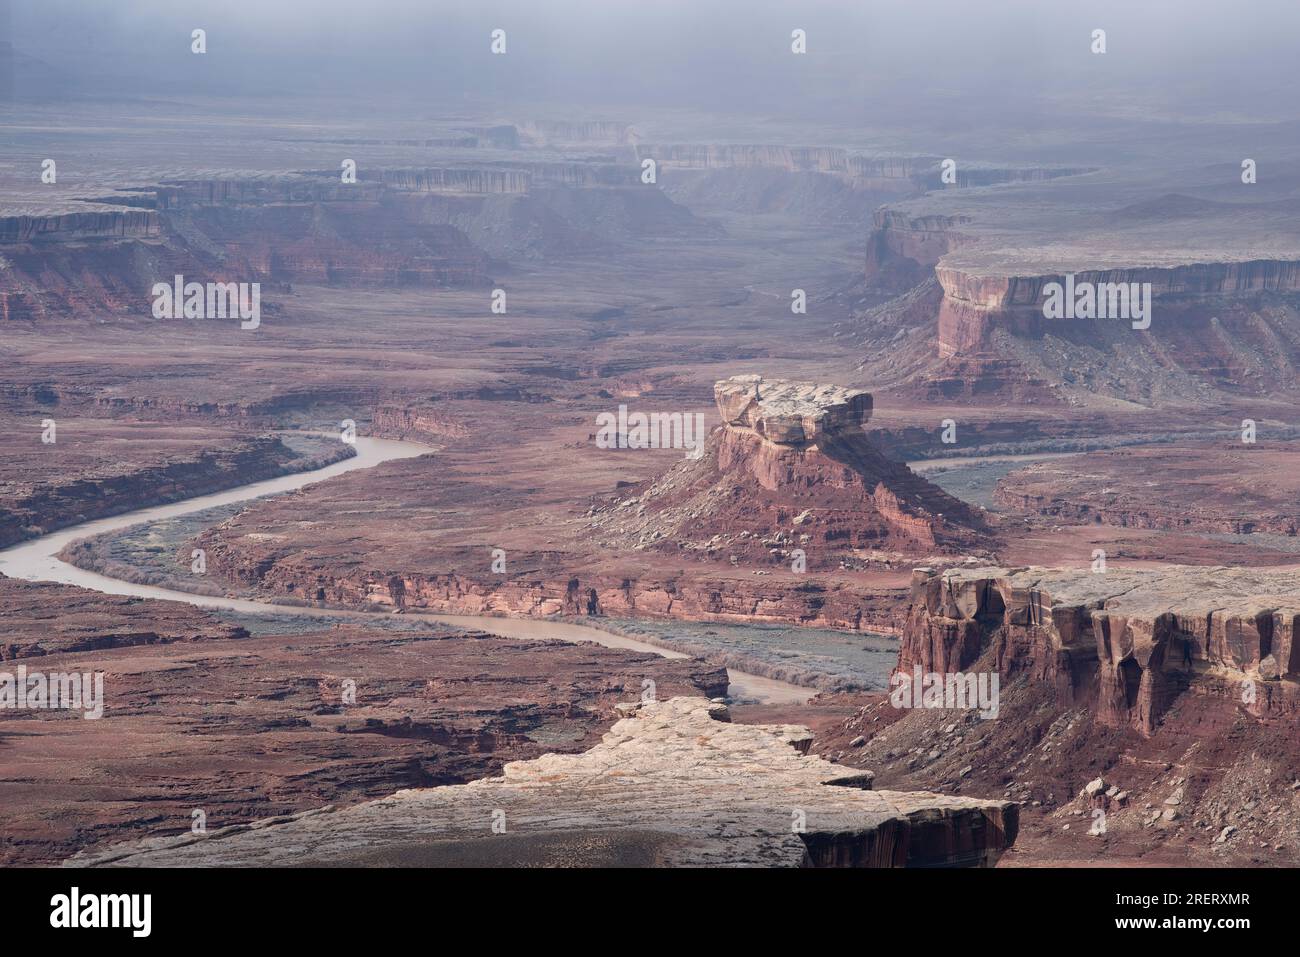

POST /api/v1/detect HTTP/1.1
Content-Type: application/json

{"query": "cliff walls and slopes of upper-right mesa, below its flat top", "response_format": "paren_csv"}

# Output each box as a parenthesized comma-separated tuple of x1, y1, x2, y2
(859, 205, 1300, 404)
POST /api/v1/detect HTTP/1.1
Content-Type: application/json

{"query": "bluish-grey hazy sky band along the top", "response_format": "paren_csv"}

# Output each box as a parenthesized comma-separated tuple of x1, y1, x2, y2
(0, 0, 1300, 123)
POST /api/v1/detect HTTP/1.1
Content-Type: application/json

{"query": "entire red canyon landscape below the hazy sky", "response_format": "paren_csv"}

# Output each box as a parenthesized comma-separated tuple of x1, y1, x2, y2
(0, 1, 1300, 867)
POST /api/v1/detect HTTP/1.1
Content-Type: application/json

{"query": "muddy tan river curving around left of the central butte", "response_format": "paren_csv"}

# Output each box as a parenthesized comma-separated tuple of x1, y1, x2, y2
(0, 436, 814, 703)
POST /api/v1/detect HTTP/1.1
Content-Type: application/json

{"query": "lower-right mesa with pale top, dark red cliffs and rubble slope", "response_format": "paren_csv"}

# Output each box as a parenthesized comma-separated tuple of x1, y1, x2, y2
(814, 566, 1300, 867)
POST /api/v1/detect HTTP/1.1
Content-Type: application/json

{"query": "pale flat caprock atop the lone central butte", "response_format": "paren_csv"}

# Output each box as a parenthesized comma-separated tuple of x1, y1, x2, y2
(714, 374, 872, 447)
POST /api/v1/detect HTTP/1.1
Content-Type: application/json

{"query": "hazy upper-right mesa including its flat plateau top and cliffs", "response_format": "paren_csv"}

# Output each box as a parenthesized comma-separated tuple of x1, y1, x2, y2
(866, 184, 1300, 403)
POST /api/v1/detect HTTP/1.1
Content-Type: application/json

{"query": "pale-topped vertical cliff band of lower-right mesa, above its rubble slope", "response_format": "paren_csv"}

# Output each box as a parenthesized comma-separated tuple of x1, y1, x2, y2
(898, 566, 1300, 736)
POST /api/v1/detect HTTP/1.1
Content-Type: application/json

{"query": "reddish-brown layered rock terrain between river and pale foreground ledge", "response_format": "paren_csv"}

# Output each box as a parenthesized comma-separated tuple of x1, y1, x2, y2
(0, 605, 727, 866)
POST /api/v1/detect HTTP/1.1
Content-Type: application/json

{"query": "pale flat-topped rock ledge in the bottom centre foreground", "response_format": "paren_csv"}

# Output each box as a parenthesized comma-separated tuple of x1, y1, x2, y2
(69, 697, 1019, 866)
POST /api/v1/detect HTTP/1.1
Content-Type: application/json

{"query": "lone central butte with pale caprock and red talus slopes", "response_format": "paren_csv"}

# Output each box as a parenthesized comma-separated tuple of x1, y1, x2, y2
(597, 374, 992, 570)
